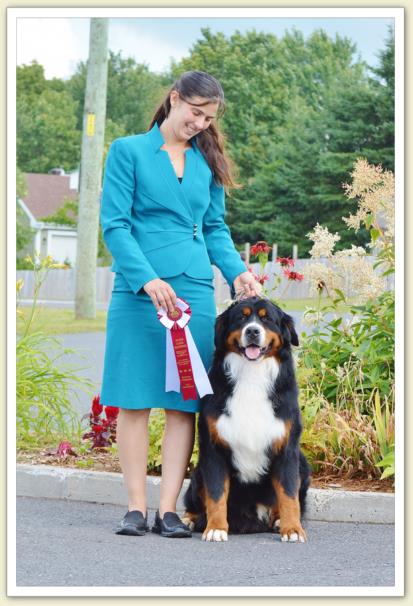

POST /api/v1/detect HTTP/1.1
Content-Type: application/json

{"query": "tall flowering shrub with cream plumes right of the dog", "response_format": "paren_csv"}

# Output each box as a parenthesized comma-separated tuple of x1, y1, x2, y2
(298, 159, 395, 477)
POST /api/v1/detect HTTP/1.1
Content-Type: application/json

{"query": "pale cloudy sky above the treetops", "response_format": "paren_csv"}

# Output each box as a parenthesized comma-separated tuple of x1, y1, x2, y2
(17, 17, 394, 79)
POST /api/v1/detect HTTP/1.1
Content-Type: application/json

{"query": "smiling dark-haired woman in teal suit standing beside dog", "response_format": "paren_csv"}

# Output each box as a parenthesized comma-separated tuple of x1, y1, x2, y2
(101, 71, 260, 537)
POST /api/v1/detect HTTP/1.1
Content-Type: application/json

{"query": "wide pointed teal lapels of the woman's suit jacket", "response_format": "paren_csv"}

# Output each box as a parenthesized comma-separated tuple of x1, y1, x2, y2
(147, 122, 199, 223)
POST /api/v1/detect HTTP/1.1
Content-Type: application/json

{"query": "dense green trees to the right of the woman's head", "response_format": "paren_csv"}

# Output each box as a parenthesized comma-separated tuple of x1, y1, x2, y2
(172, 28, 394, 257)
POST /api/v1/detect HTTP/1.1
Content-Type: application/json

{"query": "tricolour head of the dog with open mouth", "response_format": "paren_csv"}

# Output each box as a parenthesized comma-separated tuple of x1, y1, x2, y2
(215, 297, 298, 362)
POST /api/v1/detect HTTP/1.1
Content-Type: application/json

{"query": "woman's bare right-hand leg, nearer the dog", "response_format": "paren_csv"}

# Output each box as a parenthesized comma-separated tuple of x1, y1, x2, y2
(159, 410, 195, 518)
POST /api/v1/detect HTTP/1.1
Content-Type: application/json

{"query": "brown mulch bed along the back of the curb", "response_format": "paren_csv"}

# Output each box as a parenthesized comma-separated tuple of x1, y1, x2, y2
(17, 451, 394, 492)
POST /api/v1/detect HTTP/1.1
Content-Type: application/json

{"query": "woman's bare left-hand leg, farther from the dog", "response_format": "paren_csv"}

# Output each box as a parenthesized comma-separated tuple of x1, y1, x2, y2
(116, 408, 150, 515)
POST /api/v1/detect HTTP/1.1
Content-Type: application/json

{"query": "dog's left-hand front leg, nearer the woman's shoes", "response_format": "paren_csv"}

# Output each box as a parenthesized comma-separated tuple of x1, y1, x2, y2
(202, 446, 229, 541)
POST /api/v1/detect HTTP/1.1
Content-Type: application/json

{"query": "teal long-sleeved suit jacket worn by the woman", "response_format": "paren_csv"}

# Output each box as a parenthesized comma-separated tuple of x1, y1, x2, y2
(100, 123, 246, 293)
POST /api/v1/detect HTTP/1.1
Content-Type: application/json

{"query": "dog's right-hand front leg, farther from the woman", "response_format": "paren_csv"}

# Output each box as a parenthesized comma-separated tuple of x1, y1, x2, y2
(273, 455, 307, 543)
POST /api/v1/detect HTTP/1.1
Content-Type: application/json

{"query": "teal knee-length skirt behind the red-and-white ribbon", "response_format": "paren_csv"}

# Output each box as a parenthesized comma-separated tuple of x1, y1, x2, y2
(100, 273, 216, 412)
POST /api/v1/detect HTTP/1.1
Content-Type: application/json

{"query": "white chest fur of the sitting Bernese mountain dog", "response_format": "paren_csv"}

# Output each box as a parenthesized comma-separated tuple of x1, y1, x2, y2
(216, 352, 286, 483)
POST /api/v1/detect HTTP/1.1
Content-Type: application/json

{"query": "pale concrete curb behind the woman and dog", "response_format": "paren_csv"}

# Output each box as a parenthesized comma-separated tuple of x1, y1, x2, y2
(16, 463, 394, 524)
